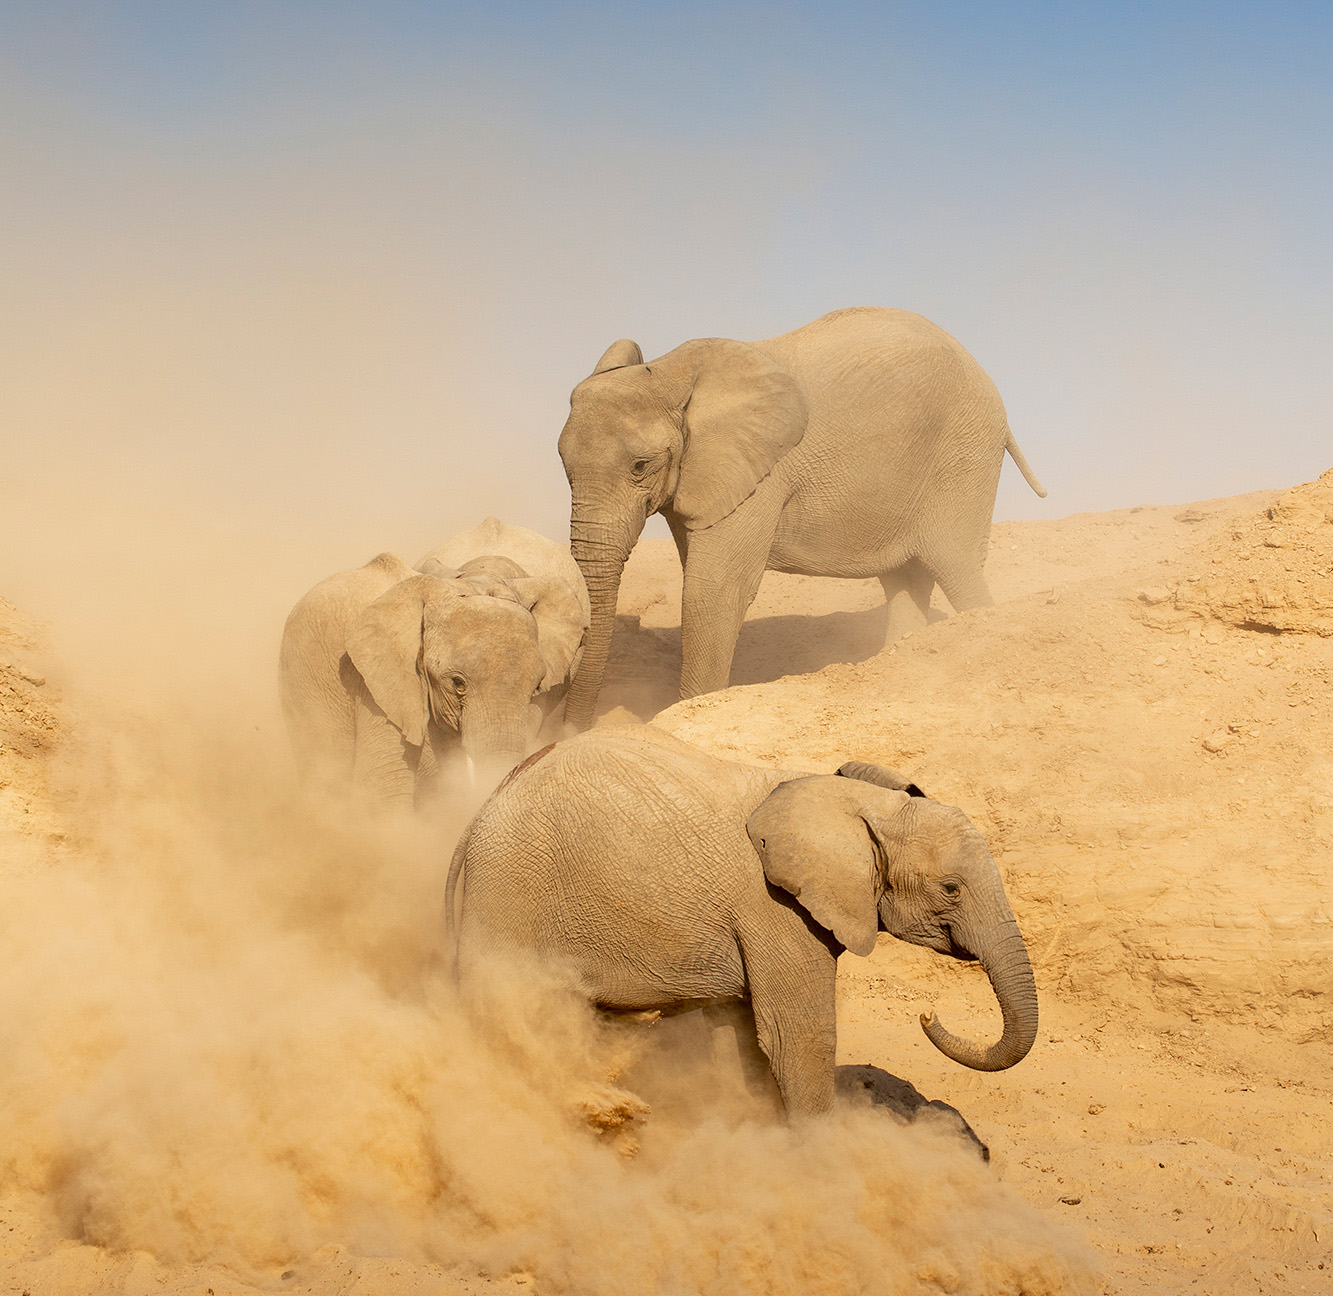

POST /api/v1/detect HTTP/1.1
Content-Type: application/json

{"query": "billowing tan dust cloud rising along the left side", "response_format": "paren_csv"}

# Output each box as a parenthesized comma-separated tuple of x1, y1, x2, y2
(0, 78, 1090, 1274)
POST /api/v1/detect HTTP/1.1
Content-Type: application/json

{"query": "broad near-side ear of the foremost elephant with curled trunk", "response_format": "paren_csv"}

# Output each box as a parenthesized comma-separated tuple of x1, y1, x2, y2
(745, 776, 881, 956)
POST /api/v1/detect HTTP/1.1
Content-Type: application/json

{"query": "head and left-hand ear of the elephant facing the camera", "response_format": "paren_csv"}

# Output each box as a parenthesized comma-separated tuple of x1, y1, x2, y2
(347, 576, 547, 780)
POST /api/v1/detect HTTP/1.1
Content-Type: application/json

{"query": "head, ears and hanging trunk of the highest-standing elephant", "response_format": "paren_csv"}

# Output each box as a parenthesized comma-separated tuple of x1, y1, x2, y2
(560, 337, 806, 727)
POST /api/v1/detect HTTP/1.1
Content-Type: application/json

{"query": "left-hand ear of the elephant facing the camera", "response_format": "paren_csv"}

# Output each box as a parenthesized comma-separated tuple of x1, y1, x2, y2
(347, 576, 443, 747)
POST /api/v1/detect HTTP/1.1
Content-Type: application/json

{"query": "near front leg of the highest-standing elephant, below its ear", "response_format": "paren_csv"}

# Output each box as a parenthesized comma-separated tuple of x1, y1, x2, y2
(680, 495, 780, 697)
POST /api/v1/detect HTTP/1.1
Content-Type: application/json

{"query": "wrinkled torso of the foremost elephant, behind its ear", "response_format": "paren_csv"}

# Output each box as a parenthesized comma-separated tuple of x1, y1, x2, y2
(460, 725, 765, 1007)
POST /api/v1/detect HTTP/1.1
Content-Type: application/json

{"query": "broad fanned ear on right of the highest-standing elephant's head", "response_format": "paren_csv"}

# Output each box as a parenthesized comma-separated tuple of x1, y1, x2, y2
(672, 337, 808, 531)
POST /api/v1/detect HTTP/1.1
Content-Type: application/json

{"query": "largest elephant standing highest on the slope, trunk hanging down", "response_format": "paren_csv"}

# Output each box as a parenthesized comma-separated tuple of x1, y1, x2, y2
(560, 307, 1046, 728)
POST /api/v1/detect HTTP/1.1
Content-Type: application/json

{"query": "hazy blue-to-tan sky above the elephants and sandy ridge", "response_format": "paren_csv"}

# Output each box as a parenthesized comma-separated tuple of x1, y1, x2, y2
(0, 0, 1333, 561)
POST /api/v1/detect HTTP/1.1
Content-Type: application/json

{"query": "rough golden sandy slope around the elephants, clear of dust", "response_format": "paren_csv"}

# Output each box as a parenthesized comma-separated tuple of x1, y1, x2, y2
(0, 480, 1333, 1296)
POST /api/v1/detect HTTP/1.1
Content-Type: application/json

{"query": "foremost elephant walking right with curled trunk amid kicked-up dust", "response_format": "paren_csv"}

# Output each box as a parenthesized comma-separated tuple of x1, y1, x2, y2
(444, 724, 1037, 1117)
